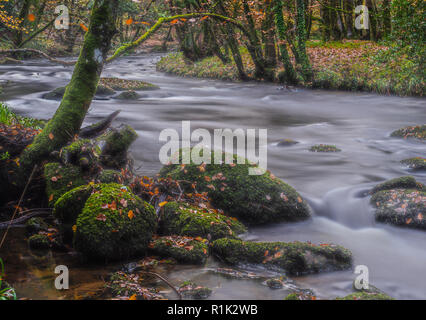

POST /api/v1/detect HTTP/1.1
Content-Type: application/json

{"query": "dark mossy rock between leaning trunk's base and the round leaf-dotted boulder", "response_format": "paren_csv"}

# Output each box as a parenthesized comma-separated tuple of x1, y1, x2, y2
(44, 162, 87, 205)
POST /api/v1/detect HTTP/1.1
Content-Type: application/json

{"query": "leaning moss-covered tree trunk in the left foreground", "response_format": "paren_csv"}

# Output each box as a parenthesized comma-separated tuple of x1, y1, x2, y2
(21, 0, 119, 176)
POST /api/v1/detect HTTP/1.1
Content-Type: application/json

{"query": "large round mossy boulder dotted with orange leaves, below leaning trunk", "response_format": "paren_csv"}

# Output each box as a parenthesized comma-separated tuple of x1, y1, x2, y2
(74, 183, 157, 260)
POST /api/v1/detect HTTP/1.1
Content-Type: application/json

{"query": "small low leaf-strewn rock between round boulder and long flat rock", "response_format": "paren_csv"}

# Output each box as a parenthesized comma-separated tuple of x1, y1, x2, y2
(149, 236, 208, 264)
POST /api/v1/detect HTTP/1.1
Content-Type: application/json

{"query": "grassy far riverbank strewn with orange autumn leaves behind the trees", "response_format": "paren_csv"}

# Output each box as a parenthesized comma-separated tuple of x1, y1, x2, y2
(157, 40, 426, 96)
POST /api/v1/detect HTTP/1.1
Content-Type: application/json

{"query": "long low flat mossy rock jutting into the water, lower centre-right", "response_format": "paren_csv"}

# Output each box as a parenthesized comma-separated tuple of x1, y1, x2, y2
(212, 239, 352, 276)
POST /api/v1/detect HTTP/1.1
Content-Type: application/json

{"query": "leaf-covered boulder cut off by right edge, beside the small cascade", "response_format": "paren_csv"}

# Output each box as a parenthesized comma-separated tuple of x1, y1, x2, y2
(371, 189, 426, 229)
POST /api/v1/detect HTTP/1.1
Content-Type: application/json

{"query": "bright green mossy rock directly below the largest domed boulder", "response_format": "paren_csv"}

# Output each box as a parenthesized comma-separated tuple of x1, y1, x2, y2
(159, 202, 247, 240)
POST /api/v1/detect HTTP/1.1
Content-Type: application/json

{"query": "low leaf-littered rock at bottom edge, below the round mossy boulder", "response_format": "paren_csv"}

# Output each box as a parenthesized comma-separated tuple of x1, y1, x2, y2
(107, 271, 164, 300)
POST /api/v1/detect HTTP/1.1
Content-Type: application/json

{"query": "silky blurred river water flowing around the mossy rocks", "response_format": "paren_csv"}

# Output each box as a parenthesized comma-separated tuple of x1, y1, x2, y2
(0, 55, 426, 299)
